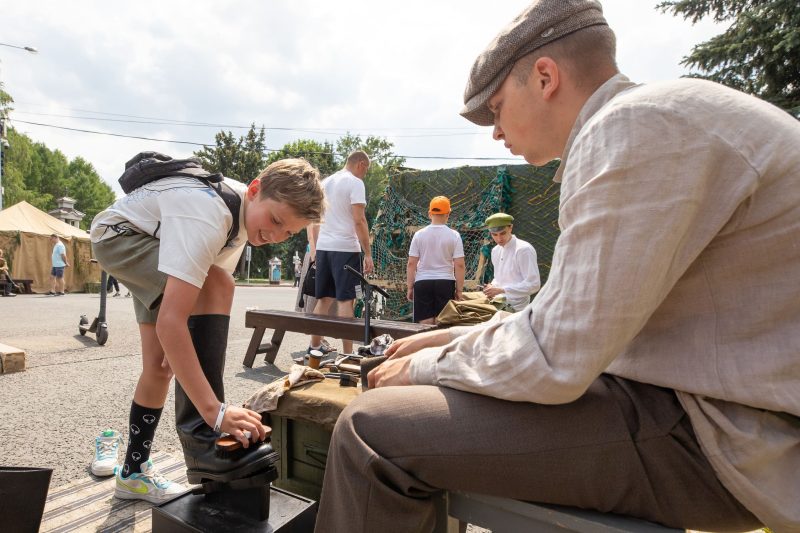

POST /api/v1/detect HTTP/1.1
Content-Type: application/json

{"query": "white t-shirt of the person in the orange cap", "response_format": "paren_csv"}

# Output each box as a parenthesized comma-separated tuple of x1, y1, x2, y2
(408, 224, 464, 281)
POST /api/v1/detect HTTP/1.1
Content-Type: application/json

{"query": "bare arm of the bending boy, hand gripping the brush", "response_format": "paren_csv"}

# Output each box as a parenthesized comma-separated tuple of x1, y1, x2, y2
(156, 276, 266, 447)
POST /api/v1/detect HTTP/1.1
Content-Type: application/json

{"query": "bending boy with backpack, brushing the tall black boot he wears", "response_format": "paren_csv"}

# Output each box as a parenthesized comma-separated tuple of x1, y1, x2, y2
(91, 152, 324, 504)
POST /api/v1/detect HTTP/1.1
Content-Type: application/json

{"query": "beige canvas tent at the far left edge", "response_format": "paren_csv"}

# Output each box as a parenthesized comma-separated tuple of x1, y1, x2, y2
(0, 202, 100, 292)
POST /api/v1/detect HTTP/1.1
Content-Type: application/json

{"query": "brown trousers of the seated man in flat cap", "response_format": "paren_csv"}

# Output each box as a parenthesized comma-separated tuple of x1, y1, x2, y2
(316, 375, 759, 533)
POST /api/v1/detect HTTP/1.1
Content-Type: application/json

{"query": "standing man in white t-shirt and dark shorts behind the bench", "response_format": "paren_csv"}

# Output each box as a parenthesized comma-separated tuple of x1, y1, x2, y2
(308, 150, 373, 353)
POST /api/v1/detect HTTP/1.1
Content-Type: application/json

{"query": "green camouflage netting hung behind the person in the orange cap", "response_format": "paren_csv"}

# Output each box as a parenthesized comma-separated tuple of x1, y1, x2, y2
(371, 164, 559, 320)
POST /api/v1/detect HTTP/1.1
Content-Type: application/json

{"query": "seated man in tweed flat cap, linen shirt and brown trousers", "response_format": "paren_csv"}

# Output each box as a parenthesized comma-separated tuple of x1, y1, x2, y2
(317, 0, 800, 533)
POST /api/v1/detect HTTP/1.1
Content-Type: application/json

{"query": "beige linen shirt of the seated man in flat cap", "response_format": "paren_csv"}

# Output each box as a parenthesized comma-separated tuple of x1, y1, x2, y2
(410, 75, 800, 531)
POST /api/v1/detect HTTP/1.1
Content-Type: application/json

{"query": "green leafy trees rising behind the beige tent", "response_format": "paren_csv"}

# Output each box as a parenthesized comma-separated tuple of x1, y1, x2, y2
(3, 128, 114, 229)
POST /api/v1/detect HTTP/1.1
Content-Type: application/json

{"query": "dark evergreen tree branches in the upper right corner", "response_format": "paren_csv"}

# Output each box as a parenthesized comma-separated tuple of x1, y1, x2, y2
(658, 0, 800, 118)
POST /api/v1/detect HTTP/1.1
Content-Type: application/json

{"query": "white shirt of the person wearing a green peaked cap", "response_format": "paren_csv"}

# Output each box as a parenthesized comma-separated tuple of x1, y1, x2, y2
(484, 235, 541, 311)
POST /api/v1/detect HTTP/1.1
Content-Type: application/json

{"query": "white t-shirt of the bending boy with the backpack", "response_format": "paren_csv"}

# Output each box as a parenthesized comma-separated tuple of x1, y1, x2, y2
(90, 177, 247, 288)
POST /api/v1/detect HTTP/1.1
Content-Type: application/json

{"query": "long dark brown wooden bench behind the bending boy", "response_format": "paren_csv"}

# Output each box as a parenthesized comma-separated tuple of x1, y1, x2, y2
(242, 309, 436, 368)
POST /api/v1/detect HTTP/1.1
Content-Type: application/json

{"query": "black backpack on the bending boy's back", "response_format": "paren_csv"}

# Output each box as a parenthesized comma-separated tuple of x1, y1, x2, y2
(118, 152, 242, 246)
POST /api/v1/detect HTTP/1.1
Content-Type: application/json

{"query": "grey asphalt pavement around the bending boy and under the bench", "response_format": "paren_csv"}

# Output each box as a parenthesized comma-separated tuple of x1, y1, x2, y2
(0, 287, 318, 488)
